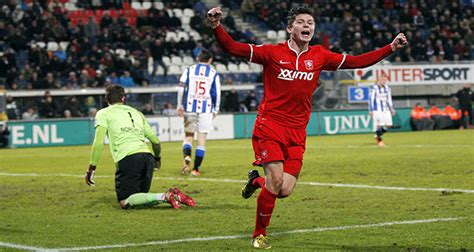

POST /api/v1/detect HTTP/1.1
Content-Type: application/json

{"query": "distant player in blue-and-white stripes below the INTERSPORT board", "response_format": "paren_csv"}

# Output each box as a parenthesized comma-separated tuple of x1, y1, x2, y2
(369, 76, 395, 147)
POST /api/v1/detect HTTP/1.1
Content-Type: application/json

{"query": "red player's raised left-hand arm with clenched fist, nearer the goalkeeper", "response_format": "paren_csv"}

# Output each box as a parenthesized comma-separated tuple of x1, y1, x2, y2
(207, 7, 251, 58)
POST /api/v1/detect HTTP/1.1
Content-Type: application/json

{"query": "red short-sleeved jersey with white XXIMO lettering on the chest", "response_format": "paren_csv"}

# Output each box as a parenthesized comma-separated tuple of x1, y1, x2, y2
(249, 42, 345, 129)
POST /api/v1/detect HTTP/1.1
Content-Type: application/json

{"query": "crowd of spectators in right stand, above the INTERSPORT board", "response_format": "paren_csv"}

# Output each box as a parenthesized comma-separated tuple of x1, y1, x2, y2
(231, 0, 474, 62)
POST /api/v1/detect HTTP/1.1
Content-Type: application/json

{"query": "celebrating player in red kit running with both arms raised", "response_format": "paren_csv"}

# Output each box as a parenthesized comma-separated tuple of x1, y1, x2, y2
(208, 6, 407, 249)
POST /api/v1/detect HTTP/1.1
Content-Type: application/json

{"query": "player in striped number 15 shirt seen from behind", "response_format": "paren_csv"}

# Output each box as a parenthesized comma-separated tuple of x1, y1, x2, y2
(178, 49, 221, 176)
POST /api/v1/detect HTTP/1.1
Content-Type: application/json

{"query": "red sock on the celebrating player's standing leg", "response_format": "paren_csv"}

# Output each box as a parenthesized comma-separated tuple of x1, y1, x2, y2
(253, 187, 277, 238)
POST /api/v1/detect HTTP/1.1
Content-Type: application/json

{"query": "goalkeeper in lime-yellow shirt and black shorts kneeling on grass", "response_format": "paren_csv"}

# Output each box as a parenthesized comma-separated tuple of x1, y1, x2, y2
(85, 85, 196, 209)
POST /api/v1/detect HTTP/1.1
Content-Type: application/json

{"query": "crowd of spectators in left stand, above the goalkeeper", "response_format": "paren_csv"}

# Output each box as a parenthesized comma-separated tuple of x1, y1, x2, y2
(0, 0, 260, 93)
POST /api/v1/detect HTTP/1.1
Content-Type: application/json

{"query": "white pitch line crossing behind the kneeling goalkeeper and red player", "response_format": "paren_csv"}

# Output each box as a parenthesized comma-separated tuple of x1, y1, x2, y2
(0, 172, 474, 193)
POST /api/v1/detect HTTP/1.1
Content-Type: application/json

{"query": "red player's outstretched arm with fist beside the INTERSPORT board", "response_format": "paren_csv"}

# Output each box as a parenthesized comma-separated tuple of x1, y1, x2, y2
(341, 33, 408, 69)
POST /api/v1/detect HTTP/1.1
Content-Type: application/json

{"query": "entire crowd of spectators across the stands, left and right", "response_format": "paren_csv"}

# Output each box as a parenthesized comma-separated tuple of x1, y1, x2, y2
(0, 0, 474, 118)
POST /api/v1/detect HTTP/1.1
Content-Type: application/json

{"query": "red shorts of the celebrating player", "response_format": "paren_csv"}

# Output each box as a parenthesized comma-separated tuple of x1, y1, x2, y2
(252, 117, 306, 178)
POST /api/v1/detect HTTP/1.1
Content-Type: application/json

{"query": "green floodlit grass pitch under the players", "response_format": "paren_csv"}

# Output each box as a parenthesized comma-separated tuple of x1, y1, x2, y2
(0, 130, 474, 251)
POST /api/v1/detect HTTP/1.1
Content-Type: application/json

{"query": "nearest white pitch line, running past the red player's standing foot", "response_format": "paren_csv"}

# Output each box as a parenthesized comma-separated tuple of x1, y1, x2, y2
(30, 217, 466, 251)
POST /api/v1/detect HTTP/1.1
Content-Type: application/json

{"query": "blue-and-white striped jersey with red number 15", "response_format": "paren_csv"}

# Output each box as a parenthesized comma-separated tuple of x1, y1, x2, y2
(178, 64, 221, 113)
